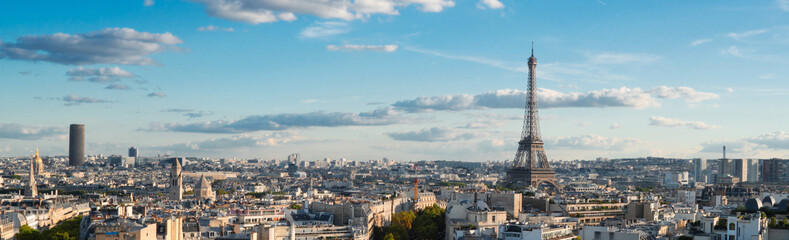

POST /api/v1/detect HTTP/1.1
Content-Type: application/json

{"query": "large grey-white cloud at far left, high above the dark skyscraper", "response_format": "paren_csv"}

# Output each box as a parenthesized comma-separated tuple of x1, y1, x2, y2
(0, 28, 183, 65)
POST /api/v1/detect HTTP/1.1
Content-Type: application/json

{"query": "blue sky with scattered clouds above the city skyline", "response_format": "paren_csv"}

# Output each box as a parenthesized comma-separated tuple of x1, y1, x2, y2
(0, 0, 789, 161)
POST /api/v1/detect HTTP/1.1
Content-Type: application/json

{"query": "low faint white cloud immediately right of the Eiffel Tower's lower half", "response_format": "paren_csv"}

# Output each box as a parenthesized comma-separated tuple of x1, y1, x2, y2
(545, 135, 641, 150)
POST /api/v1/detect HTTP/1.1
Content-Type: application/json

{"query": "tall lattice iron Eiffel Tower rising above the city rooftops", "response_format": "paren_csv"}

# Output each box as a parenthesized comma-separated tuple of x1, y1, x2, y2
(505, 46, 558, 188)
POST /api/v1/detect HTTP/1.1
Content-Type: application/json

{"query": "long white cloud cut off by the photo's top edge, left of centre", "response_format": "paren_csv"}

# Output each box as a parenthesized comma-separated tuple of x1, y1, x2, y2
(190, 0, 455, 24)
